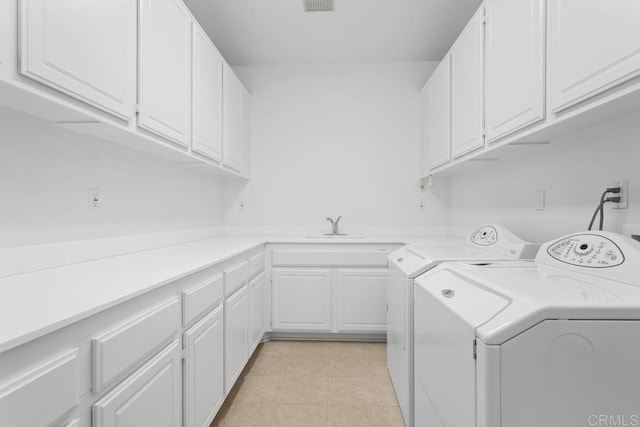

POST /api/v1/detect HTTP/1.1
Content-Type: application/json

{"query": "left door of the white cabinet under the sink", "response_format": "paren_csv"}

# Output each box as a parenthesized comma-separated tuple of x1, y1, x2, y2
(272, 268, 331, 332)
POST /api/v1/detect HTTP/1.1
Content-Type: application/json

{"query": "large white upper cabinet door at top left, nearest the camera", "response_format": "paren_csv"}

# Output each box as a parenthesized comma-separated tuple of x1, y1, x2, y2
(20, 0, 136, 120)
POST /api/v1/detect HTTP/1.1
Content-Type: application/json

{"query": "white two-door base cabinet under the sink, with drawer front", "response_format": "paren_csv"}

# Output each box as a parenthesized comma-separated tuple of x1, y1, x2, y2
(271, 243, 400, 336)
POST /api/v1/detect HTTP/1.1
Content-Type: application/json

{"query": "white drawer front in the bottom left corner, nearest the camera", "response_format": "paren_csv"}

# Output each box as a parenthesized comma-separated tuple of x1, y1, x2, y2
(0, 349, 78, 426)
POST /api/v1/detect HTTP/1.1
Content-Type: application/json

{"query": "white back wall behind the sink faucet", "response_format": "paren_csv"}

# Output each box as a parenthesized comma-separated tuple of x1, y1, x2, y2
(225, 63, 446, 233)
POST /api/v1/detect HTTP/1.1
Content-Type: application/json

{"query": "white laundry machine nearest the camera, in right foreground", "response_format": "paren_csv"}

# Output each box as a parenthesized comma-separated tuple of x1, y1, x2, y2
(415, 232, 640, 427)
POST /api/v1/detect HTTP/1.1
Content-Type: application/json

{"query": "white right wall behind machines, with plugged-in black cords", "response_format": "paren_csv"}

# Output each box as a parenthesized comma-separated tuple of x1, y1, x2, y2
(438, 110, 640, 242)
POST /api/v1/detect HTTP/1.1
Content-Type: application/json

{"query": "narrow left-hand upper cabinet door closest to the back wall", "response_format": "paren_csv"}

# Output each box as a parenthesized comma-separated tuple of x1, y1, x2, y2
(222, 64, 250, 174)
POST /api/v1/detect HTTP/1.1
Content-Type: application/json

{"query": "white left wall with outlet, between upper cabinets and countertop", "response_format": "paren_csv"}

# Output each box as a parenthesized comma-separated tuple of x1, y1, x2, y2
(0, 108, 222, 247)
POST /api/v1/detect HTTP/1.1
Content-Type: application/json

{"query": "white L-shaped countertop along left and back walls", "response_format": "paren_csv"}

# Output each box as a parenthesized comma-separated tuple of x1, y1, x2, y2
(0, 236, 448, 353)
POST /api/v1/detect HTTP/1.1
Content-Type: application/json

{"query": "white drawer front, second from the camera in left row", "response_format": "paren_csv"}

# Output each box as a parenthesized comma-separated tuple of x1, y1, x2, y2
(91, 297, 180, 392)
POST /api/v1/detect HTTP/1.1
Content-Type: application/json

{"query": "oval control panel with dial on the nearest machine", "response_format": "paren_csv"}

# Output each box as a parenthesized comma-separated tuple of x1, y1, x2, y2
(547, 234, 624, 268)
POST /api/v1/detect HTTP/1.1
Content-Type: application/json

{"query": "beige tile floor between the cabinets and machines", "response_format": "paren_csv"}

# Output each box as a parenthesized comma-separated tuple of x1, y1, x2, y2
(213, 341, 404, 427)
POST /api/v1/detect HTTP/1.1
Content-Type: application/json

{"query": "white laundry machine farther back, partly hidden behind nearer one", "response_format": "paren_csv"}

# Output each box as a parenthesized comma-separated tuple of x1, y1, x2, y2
(387, 226, 540, 426)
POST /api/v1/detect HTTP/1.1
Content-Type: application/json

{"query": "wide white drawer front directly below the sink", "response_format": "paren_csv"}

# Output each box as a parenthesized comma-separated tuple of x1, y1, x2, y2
(271, 250, 389, 267)
